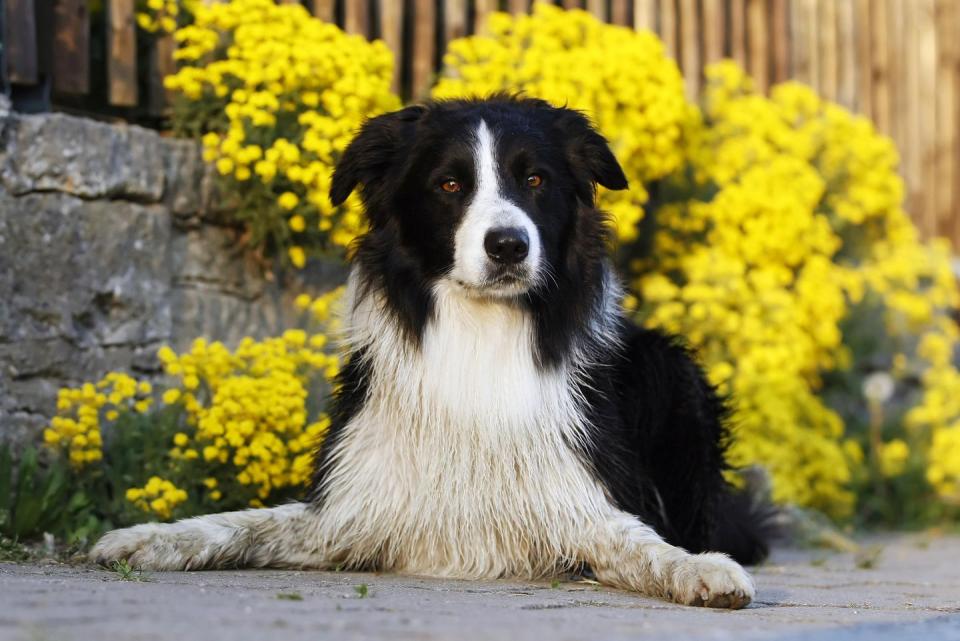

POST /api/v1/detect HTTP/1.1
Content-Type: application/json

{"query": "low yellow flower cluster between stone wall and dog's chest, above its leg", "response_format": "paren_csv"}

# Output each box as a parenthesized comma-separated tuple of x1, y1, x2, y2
(159, 330, 339, 504)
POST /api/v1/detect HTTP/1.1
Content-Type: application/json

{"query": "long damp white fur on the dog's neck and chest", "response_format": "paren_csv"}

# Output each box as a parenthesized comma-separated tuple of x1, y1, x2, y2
(321, 278, 609, 577)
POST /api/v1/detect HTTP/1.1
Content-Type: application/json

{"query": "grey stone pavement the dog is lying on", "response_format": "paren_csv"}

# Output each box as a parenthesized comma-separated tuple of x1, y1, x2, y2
(0, 535, 960, 641)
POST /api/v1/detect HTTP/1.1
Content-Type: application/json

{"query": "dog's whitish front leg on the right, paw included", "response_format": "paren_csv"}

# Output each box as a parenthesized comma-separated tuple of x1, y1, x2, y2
(583, 512, 756, 609)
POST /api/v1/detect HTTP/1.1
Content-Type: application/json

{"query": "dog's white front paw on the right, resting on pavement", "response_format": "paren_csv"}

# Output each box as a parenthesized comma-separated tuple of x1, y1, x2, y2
(670, 553, 756, 610)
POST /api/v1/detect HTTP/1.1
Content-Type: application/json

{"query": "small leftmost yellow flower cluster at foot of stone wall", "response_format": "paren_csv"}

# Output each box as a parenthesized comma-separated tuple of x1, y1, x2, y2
(43, 372, 153, 468)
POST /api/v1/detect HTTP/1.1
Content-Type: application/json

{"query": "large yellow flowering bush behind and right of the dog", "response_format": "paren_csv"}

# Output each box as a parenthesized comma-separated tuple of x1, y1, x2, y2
(434, 5, 960, 522)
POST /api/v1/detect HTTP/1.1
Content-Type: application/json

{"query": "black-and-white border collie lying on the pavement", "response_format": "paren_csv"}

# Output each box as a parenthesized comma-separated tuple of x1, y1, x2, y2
(91, 96, 767, 608)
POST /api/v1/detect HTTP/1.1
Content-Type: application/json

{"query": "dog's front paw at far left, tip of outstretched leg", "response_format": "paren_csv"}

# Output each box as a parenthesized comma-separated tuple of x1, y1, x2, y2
(87, 523, 209, 571)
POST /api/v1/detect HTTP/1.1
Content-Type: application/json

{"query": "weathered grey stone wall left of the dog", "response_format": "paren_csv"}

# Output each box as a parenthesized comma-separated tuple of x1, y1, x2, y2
(0, 96, 345, 450)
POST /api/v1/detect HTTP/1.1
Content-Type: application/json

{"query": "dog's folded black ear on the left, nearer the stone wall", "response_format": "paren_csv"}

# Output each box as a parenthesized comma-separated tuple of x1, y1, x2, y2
(330, 105, 427, 207)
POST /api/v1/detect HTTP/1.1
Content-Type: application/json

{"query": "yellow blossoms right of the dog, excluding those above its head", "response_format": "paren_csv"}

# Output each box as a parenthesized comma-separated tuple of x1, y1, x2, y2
(634, 63, 960, 515)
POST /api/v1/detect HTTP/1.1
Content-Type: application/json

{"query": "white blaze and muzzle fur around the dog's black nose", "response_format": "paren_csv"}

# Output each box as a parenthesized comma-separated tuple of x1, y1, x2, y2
(450, 120, 542, 294)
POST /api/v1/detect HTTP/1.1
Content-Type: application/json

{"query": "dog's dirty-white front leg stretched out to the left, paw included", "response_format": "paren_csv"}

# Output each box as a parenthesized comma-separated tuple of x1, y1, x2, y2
(90, 503, 331, 570)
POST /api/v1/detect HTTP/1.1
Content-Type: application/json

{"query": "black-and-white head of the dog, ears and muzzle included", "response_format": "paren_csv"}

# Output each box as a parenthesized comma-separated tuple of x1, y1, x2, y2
(330, 97, 627, 297)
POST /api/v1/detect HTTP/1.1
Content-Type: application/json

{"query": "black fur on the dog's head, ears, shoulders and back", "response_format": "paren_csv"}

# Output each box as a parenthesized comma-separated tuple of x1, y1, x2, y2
(314, 96, 767, 563)
